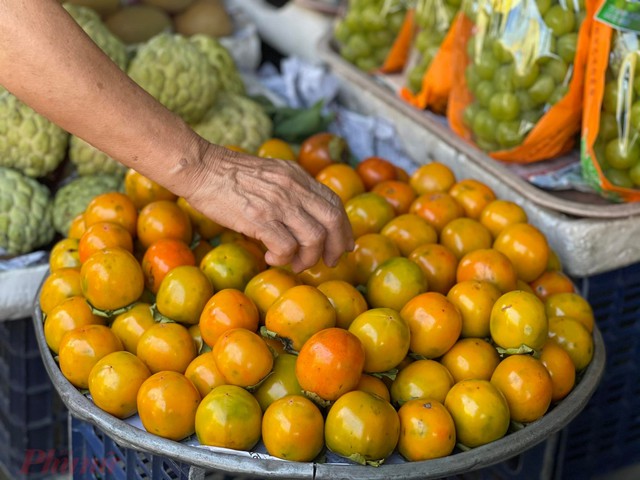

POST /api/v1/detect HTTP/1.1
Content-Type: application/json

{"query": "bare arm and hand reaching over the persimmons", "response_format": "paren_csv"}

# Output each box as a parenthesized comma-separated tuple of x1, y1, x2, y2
(0, 0, 352, 270)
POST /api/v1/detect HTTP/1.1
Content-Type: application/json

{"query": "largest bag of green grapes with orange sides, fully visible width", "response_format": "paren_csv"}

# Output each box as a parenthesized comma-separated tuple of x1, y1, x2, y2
(448, 0, 597, 163)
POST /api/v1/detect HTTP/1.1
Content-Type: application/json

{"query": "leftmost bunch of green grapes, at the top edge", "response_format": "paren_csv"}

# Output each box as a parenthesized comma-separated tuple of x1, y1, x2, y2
(334, 0, 406, 71)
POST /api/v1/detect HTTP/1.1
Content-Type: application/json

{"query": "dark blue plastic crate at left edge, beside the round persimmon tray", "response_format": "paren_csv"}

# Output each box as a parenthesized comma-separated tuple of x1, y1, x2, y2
(0, 319, 68, 479)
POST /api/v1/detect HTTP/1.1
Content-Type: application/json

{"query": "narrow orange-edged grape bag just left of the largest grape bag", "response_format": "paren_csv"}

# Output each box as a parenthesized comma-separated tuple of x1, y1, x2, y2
(400, 0, 461, 113)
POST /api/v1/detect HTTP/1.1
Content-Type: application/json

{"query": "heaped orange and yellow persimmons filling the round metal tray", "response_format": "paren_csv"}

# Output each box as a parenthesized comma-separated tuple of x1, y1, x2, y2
(40, 134, 594, 465)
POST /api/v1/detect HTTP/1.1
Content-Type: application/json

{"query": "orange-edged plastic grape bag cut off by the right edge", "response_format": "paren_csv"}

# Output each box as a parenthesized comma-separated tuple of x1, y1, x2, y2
(581, 22, 640, 201)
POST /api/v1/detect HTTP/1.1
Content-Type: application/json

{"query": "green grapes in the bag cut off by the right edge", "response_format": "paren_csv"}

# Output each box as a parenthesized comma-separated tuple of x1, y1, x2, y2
(594, 32, 640, 188)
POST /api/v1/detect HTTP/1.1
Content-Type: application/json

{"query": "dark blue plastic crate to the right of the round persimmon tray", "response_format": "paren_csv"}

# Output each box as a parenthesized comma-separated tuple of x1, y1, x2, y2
(557, 263, 640, 480)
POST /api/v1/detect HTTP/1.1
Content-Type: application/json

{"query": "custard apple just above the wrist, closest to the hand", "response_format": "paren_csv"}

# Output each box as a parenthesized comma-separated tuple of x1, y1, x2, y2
(193, 92, 273, 152)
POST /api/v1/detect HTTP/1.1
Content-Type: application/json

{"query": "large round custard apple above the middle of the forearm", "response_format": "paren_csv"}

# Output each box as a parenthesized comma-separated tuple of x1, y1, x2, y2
(129, 33, 220, 123)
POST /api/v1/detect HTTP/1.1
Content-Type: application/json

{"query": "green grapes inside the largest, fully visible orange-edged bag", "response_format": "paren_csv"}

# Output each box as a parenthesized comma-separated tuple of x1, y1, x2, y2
(463, 0, 585, 151)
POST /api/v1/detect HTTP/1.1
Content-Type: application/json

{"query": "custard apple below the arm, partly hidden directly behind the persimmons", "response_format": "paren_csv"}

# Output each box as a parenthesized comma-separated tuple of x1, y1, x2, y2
(53, 174, 122, 236)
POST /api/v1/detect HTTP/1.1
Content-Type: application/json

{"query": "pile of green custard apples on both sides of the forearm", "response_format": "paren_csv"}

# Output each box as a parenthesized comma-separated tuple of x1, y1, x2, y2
(0, 1, 272, 256)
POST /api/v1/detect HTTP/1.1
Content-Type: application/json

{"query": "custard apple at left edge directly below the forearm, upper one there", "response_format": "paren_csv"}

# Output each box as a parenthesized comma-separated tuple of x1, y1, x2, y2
(0, 89, 69, 177)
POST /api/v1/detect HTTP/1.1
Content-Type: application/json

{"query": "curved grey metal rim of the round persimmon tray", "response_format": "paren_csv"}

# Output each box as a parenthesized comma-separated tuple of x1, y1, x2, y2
(33, 282, 605, 480)
